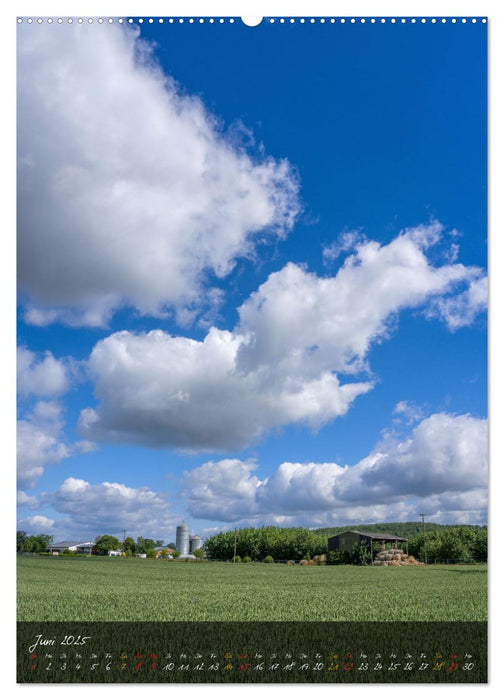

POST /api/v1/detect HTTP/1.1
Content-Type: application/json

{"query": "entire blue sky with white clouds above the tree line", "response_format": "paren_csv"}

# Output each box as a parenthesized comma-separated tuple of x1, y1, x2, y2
(17, 15, 487, 541)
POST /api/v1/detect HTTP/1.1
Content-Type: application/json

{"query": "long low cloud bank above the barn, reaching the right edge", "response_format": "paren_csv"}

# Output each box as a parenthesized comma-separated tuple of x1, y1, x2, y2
(183, 413, 487, 525)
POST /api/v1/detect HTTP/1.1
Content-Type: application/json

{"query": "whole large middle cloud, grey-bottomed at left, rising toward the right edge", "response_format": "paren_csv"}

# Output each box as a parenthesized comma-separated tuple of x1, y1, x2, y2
(80, 222, 483, 451)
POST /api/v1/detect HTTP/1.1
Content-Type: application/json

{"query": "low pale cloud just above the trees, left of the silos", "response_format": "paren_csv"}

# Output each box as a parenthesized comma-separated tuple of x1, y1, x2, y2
(40, 477, 180, 539)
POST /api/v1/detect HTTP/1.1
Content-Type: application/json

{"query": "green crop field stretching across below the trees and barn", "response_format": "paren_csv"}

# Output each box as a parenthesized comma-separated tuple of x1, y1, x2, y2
(17, 556, 487, 622)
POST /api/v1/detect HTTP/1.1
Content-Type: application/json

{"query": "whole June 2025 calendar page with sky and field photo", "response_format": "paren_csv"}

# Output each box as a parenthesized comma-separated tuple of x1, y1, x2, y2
(16, 6, 488, 684)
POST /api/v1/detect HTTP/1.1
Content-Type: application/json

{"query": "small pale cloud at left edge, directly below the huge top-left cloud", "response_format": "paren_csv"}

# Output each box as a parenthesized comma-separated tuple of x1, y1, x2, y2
(17, 347, 69, 397)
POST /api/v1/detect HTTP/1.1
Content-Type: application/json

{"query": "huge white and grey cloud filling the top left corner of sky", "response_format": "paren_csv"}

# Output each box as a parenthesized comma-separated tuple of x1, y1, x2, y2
(18, 23, 299, 326)
